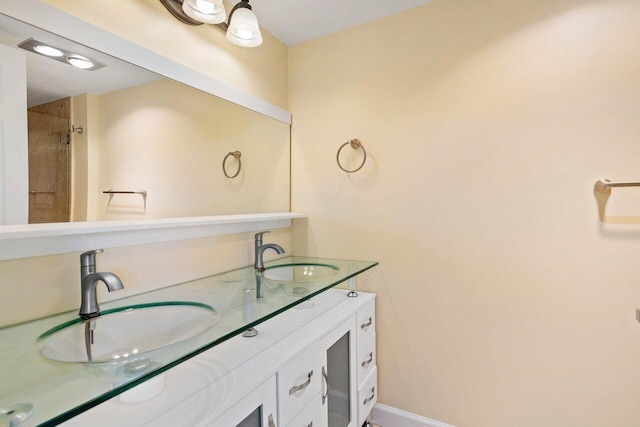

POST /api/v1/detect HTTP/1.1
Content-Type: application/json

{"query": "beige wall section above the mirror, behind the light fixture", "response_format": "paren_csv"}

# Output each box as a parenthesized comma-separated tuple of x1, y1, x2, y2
(43, 0, 287, 109)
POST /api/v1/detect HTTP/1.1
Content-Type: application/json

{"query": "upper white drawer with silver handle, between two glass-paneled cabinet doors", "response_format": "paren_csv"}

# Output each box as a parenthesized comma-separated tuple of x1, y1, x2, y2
(278, 344, 322, 426)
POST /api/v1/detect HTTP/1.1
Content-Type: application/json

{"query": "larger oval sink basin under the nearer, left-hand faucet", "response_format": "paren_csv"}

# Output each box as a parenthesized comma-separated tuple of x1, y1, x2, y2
(38, 301, 217, 369)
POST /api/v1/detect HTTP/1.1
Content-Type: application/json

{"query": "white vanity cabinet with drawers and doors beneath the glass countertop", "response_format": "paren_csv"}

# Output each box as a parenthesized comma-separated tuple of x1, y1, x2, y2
(64, 289, 377, 427)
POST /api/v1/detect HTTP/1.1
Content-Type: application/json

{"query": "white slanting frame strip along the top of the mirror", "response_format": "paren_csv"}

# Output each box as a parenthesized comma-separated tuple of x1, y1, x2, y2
(0, 0, 291, 126)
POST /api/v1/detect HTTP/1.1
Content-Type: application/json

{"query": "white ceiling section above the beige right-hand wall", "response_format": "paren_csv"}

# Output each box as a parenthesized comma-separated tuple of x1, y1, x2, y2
(251, 0, 433, 46)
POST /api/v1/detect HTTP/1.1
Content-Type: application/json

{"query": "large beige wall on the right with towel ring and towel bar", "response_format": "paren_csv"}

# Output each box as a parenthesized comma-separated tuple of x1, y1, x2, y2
(289, 0, 640, 427)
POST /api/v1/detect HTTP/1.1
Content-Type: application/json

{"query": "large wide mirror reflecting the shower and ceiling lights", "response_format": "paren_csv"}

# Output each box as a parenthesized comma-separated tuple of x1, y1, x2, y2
(0, 11, 290, 223)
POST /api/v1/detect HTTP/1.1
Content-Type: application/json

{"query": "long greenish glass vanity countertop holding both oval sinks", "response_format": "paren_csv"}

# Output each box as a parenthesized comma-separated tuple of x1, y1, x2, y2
(0, 257, 378, 426)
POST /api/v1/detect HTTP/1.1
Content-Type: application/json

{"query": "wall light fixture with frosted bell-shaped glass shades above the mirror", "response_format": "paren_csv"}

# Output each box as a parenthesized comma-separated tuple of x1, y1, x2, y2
(160, 0, 262, 47)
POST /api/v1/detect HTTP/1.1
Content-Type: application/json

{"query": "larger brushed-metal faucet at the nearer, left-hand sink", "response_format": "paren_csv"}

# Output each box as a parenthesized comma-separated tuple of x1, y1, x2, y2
(78, 249, 124, 319)
